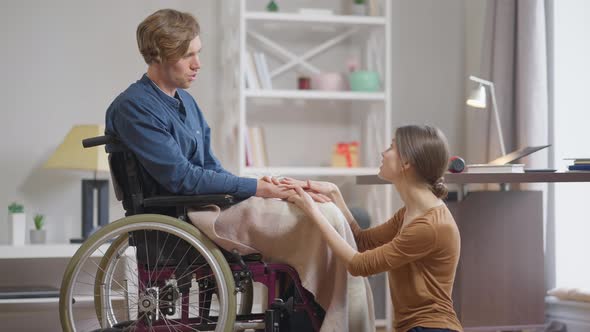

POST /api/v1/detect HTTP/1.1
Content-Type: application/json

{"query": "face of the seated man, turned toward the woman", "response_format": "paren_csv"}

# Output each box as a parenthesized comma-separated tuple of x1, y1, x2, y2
(162, 36, 201, 89)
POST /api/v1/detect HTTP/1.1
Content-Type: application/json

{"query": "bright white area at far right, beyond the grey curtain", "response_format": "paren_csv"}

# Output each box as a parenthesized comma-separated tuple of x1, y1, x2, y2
(552, 0, 590, 288)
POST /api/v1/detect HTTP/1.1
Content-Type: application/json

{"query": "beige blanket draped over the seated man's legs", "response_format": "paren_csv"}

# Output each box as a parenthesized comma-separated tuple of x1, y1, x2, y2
(189, 197, 375, 332)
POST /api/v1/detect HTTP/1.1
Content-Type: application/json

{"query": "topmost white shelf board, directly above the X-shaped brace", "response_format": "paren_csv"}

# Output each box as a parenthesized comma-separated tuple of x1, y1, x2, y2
(245, 11, 386, 26)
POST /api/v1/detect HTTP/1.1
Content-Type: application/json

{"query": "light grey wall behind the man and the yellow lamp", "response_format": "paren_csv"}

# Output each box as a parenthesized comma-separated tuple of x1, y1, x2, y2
(0, 0, 218, 243)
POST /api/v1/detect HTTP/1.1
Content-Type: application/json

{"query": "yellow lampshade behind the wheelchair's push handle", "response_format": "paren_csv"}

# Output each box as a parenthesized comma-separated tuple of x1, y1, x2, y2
(43, 125, 109, 172)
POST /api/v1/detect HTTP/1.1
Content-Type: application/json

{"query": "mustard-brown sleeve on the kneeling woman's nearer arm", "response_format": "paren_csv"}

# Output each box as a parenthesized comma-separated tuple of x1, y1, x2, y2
(348, 219, 437, 276)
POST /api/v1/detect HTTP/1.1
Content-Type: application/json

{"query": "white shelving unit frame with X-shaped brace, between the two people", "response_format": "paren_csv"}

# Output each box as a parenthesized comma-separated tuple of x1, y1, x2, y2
(237, 0, 392, 176)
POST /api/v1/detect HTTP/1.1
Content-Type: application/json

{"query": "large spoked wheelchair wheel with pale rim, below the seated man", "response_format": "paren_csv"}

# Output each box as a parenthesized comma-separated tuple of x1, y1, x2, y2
(59, 214, 236, 331)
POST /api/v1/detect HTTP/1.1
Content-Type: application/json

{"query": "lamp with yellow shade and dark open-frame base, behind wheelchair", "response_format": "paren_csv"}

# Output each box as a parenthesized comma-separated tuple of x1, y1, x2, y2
(43, 125, 109, 243)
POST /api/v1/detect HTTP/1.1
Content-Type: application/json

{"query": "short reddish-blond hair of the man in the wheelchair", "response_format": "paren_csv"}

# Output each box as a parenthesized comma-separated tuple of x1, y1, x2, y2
(136, 9, 200, 65)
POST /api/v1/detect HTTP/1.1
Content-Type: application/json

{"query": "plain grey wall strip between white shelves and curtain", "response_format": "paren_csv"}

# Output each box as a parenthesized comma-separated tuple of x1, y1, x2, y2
(392, 0, 466, 154)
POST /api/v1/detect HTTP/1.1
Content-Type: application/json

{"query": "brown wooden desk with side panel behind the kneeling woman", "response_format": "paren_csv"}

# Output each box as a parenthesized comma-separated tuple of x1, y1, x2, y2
(356, 172, 590, 331)
